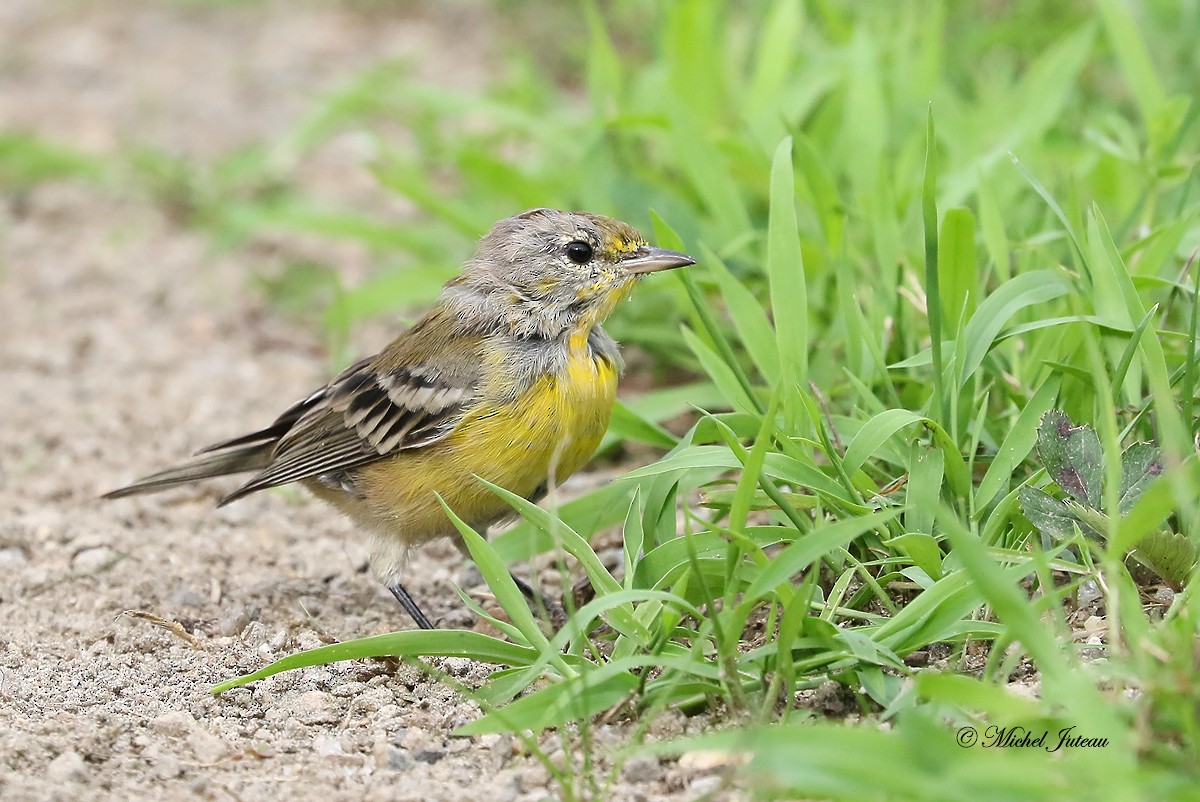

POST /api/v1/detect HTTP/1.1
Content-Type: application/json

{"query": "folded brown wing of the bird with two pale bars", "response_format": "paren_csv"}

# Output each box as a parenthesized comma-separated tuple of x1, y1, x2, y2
(215, 313, 484, 504)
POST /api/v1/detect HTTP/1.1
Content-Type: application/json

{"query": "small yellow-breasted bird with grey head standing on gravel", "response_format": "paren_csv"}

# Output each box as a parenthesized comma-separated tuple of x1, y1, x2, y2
(104, 209, 695, 629)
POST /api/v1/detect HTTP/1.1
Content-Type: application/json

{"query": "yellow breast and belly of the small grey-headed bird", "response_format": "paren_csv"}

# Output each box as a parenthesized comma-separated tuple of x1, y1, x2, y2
(359, 334, 617, 541)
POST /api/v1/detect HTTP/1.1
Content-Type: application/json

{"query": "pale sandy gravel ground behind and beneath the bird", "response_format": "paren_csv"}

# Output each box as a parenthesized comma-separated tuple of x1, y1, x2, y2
(0, 0, 737, 802)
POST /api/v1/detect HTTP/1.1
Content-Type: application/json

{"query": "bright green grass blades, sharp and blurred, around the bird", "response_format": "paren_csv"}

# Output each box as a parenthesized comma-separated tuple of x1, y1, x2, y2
(18, 0, 1200, 800)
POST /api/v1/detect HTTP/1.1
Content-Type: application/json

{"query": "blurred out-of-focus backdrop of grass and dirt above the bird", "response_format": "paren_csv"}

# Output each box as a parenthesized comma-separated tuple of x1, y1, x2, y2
(7, 0, 1200, 382)
